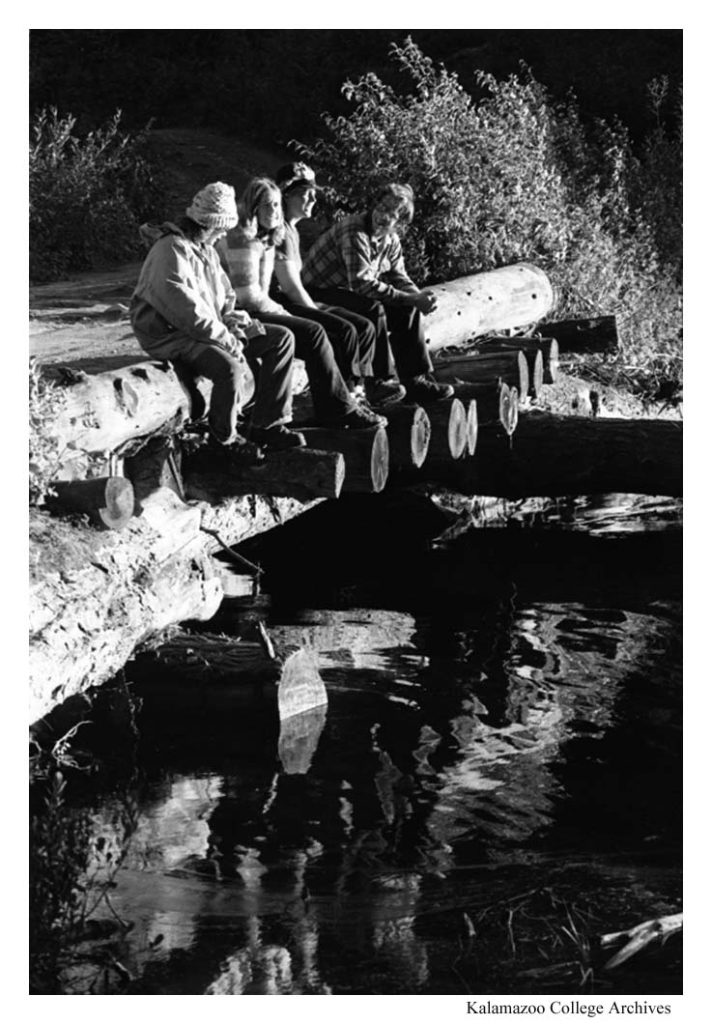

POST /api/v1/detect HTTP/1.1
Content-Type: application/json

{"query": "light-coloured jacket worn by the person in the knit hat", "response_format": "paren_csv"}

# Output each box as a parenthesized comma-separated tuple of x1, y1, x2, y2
(129, 223, 241, 359)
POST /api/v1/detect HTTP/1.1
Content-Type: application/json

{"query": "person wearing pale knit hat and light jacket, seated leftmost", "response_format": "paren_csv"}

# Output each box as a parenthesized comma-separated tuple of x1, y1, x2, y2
(129, 181, 305, 461)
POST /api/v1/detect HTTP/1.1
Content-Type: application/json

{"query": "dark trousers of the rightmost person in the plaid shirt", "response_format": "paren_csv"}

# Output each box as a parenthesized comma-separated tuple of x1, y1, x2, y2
(309, 288, 432, 380)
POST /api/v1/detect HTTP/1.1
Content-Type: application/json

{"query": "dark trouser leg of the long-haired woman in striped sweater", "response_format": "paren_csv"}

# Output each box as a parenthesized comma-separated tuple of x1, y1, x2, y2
(259, 313, 353, 421)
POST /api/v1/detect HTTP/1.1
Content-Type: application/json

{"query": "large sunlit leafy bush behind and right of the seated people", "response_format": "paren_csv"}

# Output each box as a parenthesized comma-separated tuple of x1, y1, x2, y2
(295, 39, 681, 399)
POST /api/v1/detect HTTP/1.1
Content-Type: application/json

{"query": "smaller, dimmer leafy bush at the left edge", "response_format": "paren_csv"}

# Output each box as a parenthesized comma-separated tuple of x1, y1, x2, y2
(30, 108, 160, 282)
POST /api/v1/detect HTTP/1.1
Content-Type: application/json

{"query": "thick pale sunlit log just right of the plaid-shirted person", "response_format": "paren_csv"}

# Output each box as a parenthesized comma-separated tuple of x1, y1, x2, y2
(424, 263, 554, 351)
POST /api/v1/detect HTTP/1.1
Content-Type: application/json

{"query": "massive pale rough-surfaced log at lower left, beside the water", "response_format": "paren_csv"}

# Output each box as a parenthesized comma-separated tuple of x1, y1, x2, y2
(29, 487, 323, 724)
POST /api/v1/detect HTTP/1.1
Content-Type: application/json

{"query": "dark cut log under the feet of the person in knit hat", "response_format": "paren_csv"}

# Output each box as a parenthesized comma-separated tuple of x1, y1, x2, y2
(183, 447, 346, 504)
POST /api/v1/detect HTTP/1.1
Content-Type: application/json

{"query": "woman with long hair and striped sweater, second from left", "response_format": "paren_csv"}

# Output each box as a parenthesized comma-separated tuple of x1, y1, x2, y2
(218, 178, 385, 429)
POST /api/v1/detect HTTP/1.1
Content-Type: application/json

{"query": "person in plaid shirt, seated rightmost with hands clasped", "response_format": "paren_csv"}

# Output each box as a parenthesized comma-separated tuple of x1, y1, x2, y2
(302, 184, 454, 402)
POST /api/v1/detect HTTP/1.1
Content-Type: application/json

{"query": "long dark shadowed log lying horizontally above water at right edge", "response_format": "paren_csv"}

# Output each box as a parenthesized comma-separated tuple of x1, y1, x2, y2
(432, 412, 682, 498)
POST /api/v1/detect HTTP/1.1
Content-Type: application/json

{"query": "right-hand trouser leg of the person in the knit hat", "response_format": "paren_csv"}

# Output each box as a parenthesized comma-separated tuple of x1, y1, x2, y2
(240, 324, 294, 427)
